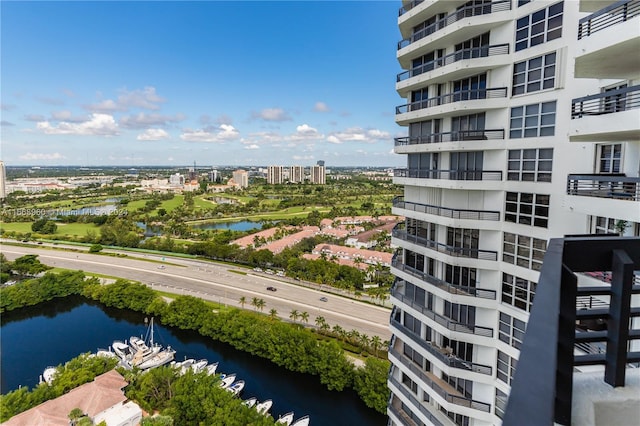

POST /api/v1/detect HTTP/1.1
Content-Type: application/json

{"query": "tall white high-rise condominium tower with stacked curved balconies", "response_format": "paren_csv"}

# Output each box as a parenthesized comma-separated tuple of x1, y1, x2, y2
(388, 0, 640, 426)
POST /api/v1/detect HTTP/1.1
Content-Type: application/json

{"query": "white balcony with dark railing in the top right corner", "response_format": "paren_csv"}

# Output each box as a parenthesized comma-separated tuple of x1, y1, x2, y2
(575, 0, 640, 79)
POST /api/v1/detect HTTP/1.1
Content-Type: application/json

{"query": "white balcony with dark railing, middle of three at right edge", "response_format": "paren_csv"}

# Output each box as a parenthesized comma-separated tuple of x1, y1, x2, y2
(569, 85, 640, 142)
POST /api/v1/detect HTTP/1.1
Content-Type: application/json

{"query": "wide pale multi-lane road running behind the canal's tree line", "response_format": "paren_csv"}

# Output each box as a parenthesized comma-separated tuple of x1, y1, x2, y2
(0, 244, 391, 340)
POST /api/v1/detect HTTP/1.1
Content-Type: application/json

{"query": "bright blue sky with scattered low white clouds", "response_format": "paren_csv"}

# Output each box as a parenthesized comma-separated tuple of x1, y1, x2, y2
(0, 0, 406, 167)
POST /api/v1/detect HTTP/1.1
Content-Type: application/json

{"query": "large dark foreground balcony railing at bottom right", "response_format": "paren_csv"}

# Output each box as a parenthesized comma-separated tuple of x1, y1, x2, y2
(502, 235, 640, 426)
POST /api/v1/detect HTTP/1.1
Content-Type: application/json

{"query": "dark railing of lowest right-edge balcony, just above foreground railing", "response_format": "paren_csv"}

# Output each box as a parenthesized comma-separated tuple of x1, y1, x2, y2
(567, 175, 640, 201)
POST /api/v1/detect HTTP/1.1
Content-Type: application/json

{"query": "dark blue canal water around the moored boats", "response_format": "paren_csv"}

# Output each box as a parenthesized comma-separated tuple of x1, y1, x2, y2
(0, 297, 387, 426)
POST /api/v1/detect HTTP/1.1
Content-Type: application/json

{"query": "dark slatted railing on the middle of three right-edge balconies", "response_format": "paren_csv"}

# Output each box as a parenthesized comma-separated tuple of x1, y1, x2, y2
(571, 85, 640, 119)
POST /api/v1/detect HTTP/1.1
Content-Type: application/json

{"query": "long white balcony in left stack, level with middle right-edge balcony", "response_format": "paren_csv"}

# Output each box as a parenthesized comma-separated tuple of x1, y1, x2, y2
(396, 87, 507, 125)
